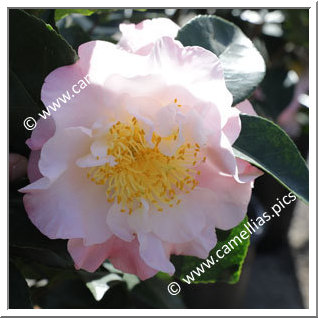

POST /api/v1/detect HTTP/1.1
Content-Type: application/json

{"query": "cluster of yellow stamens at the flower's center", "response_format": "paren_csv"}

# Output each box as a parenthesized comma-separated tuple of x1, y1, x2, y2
(87, 117, 205, 214)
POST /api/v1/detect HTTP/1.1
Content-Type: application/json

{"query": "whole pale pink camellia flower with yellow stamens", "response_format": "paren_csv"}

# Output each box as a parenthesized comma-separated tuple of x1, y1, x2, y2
(21, 20, 262, 279)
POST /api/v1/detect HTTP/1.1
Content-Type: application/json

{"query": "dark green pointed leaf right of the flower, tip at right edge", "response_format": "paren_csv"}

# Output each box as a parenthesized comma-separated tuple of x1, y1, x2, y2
(233, 115, 309, 203)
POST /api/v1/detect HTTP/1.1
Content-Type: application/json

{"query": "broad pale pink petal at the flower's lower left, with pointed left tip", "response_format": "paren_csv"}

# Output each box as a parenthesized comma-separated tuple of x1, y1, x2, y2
(20, 163, 112, 244)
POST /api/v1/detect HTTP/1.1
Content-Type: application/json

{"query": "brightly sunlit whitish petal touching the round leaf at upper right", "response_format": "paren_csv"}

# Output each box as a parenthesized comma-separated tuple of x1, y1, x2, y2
(149, 37, 233, 111)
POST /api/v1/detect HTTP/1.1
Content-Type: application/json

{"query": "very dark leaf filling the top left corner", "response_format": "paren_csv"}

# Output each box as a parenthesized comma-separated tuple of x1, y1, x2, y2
(9, 9, 77, 106)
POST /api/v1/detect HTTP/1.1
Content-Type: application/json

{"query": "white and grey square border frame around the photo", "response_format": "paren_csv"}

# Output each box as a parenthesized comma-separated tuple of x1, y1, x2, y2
(0, 0, 317, 316)
